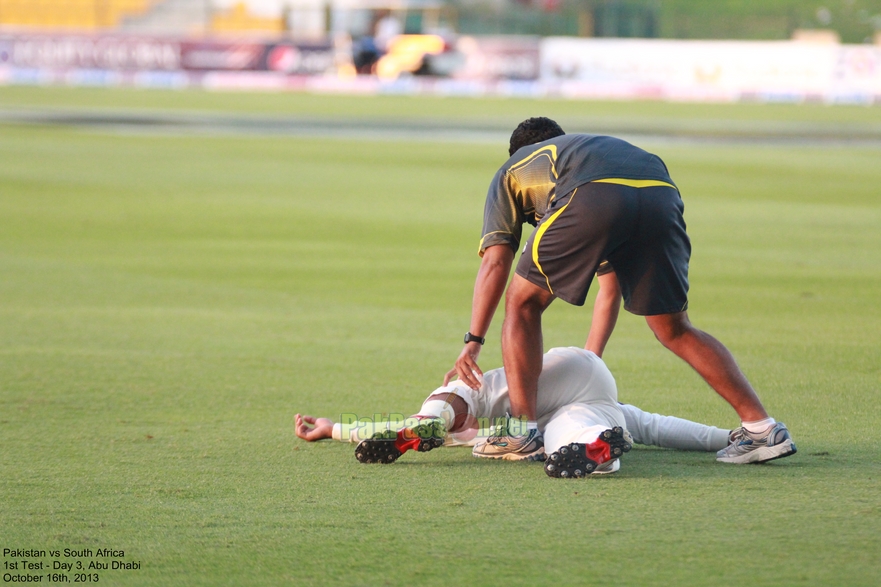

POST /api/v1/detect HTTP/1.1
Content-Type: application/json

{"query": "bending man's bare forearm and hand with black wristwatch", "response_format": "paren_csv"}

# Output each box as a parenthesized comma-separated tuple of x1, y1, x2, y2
(444, 245, 514, 389)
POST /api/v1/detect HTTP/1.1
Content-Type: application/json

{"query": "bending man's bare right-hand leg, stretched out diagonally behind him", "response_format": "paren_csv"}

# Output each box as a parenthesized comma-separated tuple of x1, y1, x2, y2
(645, 312, 768, 422)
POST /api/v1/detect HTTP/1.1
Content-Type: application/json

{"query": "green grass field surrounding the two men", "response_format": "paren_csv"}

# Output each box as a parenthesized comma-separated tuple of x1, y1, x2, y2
(0, 88, 881, 586)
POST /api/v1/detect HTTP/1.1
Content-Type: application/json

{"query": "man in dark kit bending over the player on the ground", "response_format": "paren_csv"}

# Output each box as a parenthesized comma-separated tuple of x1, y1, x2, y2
(445, 118, 796, 463)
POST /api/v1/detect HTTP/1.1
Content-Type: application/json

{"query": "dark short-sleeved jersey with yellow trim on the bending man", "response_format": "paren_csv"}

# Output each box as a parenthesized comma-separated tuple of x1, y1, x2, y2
(479, 134, 675, 256)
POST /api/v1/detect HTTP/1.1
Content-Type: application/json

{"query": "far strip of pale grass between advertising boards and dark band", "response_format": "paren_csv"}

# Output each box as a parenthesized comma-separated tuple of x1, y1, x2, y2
(0, 86, 881, 130)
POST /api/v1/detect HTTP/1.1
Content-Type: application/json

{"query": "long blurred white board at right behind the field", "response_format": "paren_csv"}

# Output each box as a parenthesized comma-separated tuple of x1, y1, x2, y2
(540, 37, 881, 100)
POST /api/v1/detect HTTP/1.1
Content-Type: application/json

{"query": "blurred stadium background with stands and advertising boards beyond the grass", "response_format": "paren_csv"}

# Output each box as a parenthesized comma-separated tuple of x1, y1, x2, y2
(0, 0, 881, 104)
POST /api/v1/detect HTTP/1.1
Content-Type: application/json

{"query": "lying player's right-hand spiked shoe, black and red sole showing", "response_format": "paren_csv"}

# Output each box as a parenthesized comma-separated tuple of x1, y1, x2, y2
(545, 426, 633, 479)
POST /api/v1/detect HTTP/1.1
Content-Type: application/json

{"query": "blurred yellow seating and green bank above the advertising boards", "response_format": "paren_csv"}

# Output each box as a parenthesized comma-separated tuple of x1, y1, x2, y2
(0, 0, 881, 43)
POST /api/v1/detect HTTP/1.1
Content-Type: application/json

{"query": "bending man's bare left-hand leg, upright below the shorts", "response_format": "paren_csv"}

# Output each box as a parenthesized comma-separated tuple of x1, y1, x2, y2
(502, 275, 554, 420)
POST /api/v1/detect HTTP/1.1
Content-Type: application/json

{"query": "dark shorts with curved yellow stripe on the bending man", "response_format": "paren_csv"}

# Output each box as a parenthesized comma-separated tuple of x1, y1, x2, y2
(517, 182, 691, 316)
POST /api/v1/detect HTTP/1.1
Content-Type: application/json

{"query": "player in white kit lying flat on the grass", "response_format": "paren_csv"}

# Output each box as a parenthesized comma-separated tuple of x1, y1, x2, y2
(296, 347, 730, 477)
